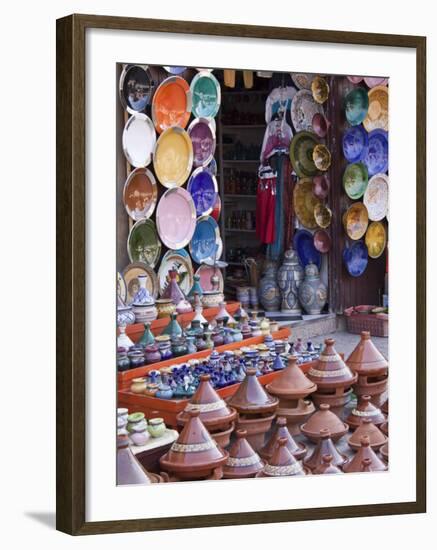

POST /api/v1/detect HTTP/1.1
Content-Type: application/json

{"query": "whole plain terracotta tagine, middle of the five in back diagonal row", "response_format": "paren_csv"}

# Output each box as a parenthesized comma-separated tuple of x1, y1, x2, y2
(266, 355, 317, 435)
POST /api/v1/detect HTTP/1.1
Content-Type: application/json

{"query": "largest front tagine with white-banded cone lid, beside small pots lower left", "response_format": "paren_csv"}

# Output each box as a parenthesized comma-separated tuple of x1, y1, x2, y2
(159, 411, 229, 481)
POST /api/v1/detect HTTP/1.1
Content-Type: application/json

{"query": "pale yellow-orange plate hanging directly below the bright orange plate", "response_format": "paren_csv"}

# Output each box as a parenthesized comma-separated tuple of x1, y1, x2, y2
(153, 126, 193, 189)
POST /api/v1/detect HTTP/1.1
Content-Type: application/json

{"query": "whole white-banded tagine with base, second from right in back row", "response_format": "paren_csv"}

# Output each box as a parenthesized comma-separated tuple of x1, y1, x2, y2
(307, 338, 358, 417)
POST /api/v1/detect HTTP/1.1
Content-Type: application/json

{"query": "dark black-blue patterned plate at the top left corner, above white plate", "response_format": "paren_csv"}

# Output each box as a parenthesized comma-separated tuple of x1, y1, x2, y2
(118, 65, 155, 113)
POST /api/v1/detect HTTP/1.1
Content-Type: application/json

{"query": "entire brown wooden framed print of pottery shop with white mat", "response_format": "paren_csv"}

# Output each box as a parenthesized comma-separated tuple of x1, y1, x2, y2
(56, 15, 426, 535)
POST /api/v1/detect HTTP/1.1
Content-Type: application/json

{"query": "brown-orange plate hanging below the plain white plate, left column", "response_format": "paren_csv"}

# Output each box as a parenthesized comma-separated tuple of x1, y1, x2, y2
(123, 168, 158, 221)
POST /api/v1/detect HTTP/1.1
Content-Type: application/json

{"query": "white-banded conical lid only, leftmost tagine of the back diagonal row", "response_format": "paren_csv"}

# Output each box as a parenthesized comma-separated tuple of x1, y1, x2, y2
(177, 374, 237, 429)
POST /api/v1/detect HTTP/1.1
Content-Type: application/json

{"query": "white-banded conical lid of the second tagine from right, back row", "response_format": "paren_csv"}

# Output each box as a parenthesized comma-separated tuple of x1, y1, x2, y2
(307, 338, 358, 389)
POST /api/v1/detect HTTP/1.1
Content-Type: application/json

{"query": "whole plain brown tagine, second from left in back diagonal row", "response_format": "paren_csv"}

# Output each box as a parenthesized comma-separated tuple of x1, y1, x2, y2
(228, 367, 278, 451)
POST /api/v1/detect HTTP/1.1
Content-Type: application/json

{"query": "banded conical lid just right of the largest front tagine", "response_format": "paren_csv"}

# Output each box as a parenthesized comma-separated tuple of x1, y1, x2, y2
(223, 430, 264, 479)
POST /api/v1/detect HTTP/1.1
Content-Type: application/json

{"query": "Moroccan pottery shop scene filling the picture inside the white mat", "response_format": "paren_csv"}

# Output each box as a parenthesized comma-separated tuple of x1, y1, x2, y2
(114, 64, 389, 485)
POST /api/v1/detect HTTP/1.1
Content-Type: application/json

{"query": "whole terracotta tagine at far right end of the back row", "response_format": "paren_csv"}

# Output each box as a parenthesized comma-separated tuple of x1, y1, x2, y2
(346, 331, 388, 407)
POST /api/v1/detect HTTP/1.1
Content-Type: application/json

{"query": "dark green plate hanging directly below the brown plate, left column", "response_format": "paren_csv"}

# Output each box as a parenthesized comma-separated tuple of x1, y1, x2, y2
(127, 220, 161, 267)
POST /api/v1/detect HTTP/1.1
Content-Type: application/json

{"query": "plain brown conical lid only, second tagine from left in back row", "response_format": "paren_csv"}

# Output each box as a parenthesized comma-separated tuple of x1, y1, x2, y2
(228, 368, 279, 414)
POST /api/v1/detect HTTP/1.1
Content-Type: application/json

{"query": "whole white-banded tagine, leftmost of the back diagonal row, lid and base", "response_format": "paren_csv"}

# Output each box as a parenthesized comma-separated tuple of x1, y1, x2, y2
(177, 374, 237, 447)
